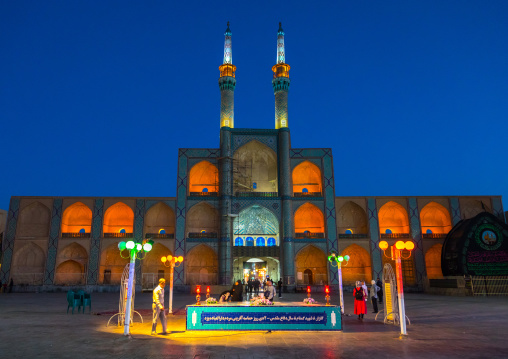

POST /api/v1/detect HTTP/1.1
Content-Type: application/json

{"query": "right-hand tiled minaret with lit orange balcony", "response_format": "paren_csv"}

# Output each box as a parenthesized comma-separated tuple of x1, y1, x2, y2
(272, 22, 290, 129)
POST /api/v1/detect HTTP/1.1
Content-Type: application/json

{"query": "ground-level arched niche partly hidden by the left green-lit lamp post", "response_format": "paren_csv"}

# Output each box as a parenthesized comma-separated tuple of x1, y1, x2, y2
(99, 243, 129, 284)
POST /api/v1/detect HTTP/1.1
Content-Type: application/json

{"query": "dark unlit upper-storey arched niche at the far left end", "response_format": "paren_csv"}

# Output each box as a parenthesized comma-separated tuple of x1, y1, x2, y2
(16, 202, 51, 237)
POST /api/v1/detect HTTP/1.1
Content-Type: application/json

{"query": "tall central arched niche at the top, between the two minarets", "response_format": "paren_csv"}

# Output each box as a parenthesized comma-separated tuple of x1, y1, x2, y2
(233, 140, 278, 192)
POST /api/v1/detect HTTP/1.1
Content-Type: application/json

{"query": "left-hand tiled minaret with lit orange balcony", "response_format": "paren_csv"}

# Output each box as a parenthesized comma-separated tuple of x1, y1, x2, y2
(219, 21, 236, 128)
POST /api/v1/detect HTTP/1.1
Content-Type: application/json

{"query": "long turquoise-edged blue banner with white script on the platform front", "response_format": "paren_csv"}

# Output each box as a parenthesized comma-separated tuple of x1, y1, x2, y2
(187, 305, 342, 331)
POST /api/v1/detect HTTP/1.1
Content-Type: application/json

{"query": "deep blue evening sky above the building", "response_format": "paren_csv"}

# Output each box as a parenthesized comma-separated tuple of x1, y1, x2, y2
(0, 0, 508, 210)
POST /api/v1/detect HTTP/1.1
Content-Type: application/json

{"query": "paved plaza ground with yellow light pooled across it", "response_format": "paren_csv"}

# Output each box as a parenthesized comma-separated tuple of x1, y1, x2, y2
(0, 293, 508, 359)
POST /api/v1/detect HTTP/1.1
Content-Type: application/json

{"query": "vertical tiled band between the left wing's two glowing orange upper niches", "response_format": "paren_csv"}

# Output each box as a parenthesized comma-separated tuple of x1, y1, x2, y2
(87, 198, 104, 285)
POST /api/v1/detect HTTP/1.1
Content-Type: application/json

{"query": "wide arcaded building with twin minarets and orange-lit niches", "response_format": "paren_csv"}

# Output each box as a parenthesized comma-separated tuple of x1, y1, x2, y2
(0, 24, 504, 290)
